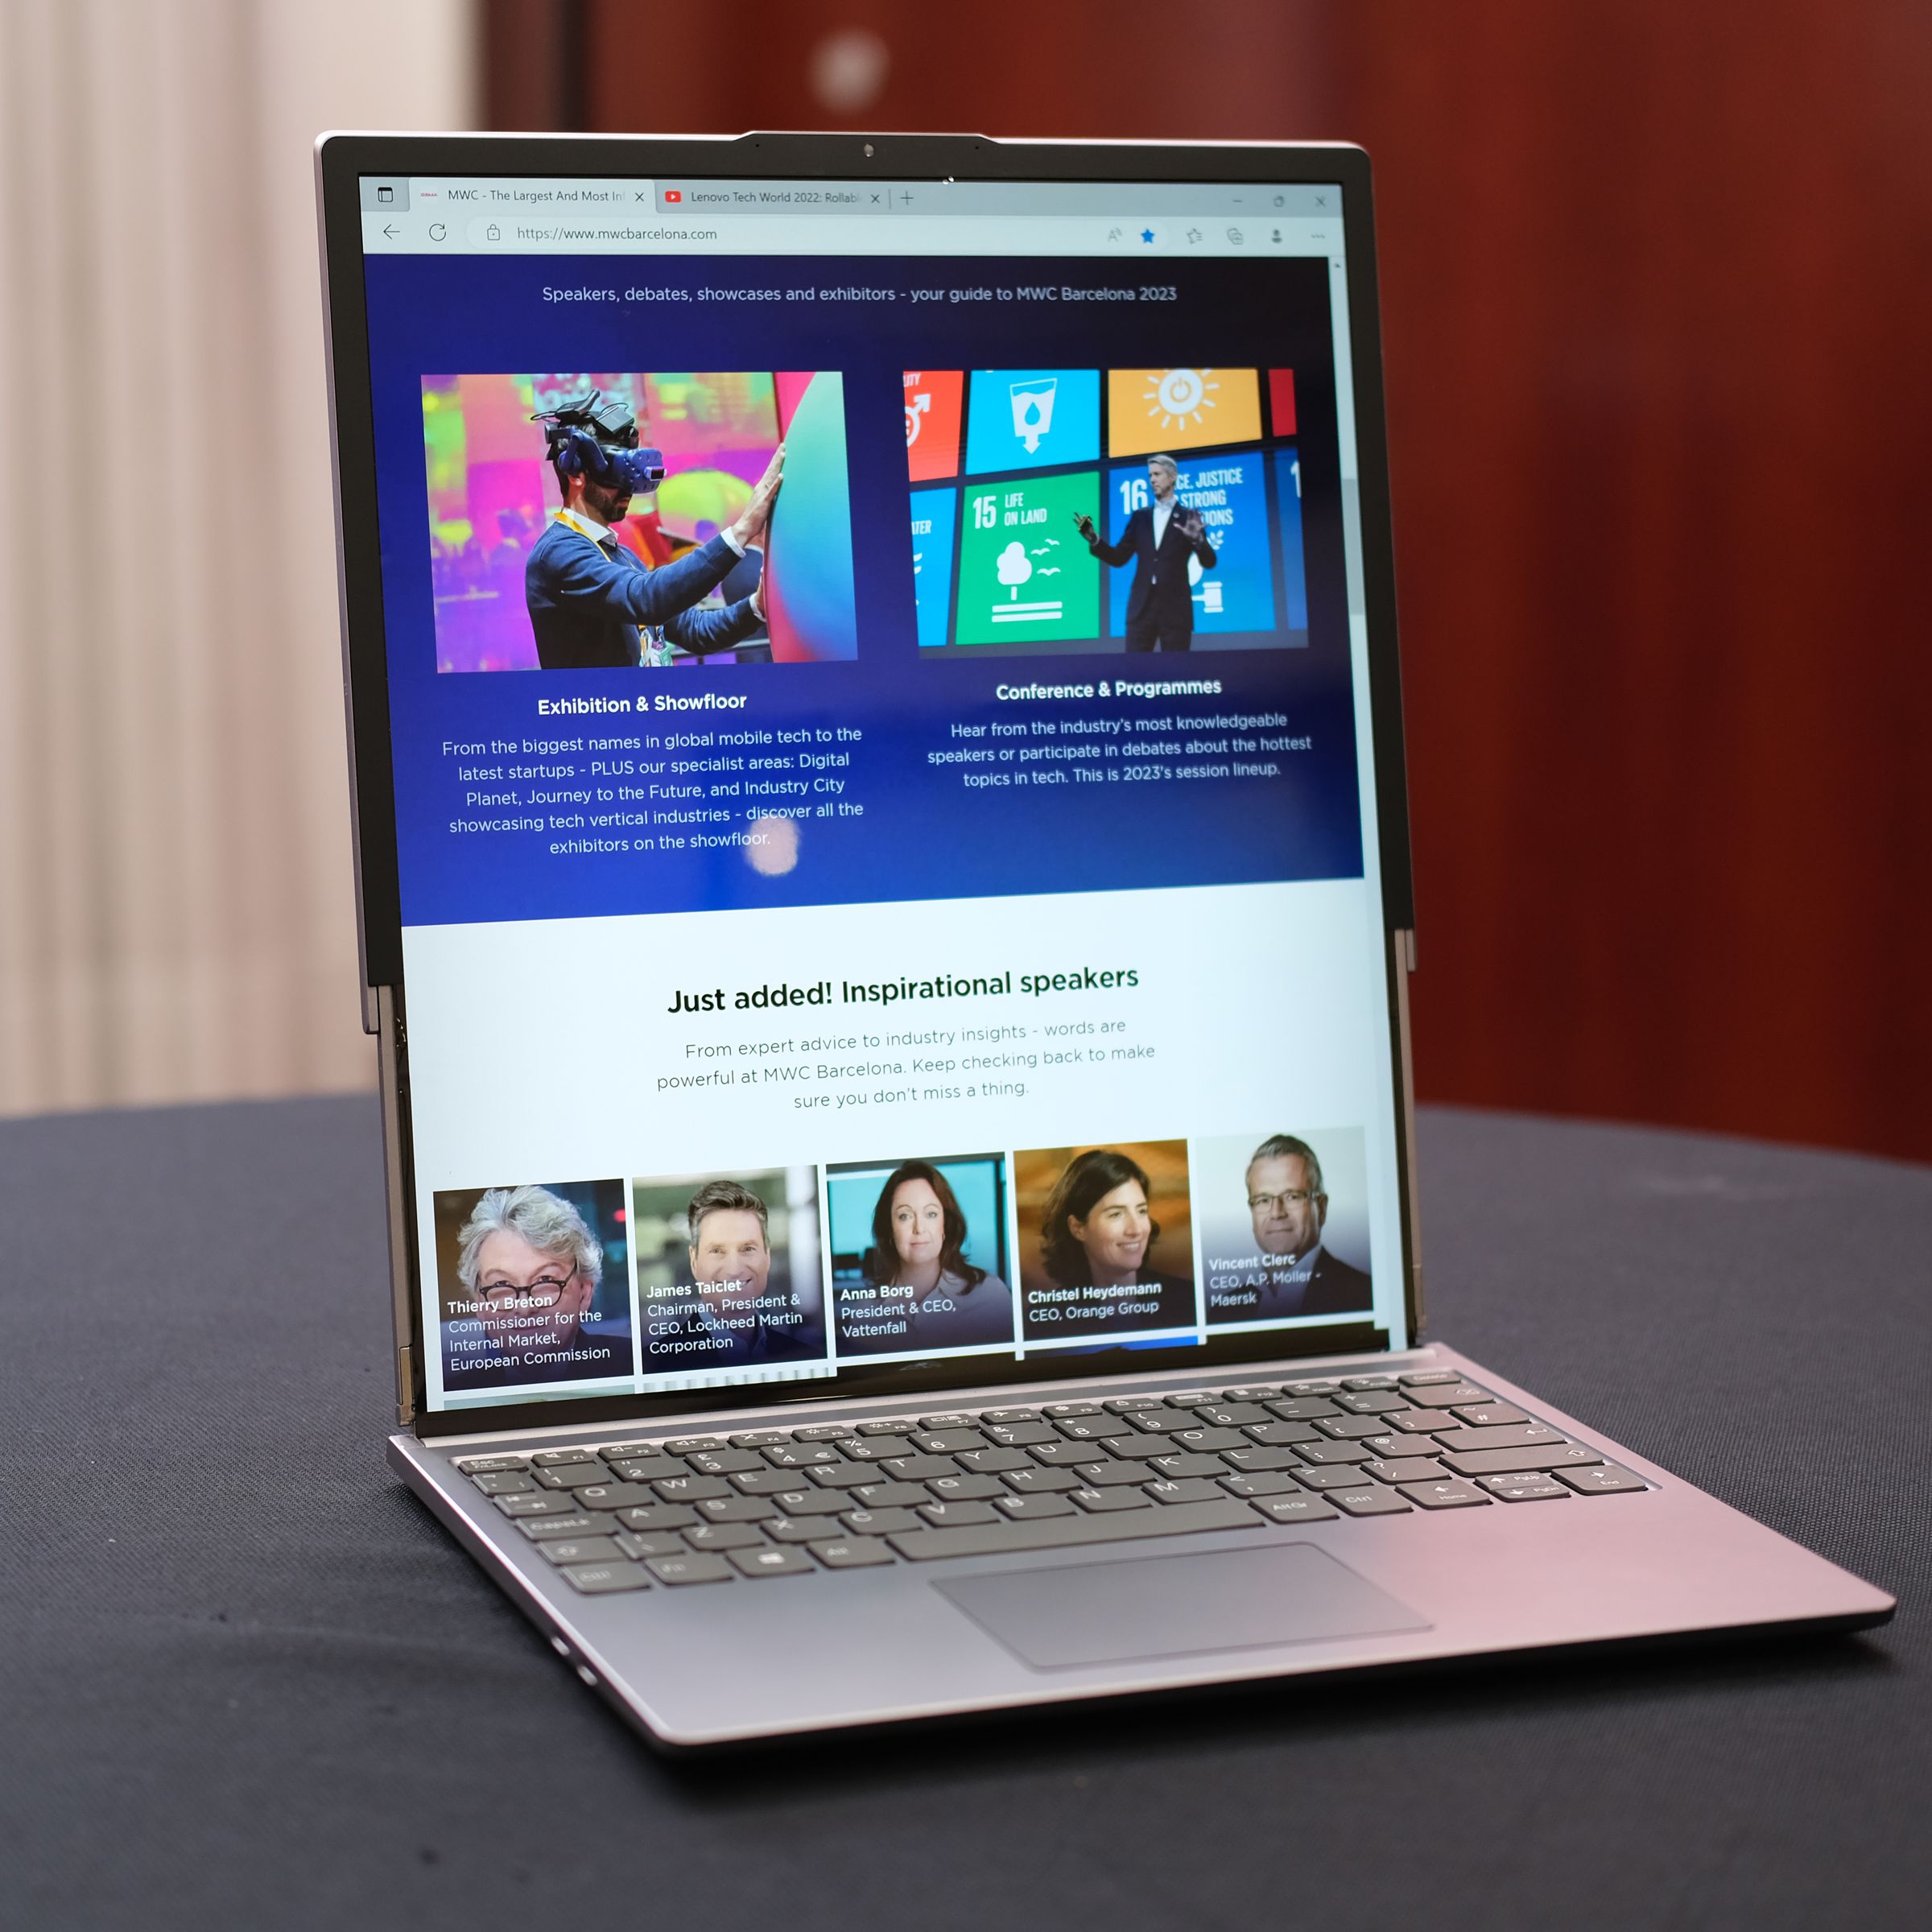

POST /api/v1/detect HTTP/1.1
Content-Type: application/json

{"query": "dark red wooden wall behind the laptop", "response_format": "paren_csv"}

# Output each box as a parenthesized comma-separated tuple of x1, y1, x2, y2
(485, 0, 1932, 1159)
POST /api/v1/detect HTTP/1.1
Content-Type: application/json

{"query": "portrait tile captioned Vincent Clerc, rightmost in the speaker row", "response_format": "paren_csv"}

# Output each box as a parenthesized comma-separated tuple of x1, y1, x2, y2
(1194, 1129, 1373, 1322)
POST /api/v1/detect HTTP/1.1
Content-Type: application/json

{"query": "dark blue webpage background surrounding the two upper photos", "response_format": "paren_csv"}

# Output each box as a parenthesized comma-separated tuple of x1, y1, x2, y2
(365, 255, 1362, 926)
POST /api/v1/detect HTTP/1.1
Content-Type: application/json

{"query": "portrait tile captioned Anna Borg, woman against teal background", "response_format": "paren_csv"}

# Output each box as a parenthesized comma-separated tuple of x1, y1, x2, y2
(825, 1154, 1013, 1358)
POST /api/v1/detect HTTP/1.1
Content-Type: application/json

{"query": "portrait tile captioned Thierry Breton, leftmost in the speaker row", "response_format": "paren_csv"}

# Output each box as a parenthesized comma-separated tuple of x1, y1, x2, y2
(435, 1180, 636, 1399)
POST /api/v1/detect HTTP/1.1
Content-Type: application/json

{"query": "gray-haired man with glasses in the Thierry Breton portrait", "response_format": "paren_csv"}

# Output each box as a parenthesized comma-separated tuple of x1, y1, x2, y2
(443, 1187, 634, 1393)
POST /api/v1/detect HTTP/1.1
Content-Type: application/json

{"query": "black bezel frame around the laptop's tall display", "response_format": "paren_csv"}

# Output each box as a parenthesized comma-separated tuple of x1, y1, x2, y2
(317, 134, 1422, 1435)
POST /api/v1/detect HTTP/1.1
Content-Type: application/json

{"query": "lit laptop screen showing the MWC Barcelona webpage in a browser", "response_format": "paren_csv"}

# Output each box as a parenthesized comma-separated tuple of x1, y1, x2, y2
(348, 162, 1409, 1410)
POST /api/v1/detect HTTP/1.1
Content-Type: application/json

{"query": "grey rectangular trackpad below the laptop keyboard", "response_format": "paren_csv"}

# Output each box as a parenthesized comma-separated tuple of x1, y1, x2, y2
(933, 1544, 1430, 1671)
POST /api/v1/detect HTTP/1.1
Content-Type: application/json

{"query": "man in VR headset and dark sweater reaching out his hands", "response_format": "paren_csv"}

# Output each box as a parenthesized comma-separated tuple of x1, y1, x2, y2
(523, 388, 784, 671)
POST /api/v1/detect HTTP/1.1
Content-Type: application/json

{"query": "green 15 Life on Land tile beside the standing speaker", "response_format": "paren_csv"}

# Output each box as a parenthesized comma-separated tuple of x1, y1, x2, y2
(955, 469, 1100, 646)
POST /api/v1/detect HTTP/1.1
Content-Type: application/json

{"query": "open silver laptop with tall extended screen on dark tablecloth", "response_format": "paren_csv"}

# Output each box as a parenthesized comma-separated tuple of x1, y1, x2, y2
(317, 134, 1893, 1750)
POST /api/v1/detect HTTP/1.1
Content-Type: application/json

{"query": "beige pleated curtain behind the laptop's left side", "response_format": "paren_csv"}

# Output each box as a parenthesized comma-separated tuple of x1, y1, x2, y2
(0, 0, 477, 1113)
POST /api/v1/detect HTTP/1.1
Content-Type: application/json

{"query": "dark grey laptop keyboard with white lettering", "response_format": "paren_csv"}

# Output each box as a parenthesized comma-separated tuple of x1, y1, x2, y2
(456, 1370, 1648, 1596)
